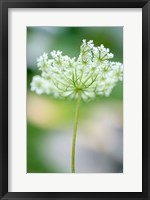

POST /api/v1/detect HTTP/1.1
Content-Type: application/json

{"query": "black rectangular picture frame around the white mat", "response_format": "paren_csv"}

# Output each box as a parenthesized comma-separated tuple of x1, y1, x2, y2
(0, 0, 150, 200)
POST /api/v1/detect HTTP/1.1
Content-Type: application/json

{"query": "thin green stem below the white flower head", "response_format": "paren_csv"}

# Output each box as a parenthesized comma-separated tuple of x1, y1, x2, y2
(71, 93, 81, 173)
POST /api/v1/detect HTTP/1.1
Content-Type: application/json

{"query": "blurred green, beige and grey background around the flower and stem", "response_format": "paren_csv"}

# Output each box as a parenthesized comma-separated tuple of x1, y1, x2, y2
(27, 26, 123, 173)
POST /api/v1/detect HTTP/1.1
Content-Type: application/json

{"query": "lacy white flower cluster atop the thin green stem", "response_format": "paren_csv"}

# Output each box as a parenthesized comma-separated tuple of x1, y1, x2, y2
(31, 40, 123, 101)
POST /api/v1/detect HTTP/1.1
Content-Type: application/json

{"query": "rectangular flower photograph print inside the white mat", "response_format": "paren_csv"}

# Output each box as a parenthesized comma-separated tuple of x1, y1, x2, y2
(26, 26, 124, 173)
